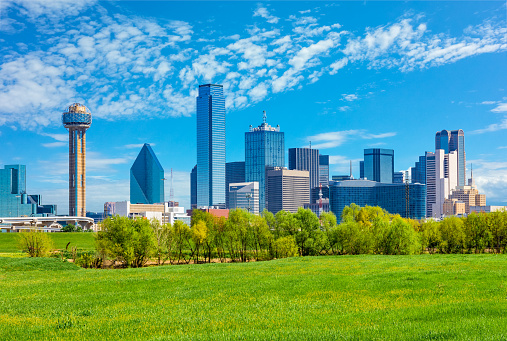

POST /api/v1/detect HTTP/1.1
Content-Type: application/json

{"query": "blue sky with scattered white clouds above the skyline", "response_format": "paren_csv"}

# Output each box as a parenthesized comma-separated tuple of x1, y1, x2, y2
(0, 0, 507, 214)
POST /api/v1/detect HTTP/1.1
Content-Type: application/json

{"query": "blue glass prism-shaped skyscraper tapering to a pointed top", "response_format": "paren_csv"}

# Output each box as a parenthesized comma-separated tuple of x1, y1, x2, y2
(130, 143, 165, 204)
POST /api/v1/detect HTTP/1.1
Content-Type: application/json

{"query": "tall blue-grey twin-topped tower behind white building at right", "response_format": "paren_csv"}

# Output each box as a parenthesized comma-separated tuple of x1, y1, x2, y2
(435, 129, 466, 186)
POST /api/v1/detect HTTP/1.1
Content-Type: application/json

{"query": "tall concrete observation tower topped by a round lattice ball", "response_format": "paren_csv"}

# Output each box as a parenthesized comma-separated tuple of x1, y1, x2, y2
(62, 103, 92, 217)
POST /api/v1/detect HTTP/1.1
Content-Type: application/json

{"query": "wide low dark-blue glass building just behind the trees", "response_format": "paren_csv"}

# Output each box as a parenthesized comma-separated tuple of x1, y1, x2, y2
(329, 180, 426, 219)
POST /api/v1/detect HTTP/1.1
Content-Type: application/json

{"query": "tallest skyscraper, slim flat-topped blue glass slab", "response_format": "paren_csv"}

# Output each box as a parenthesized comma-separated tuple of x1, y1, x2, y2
(196, 84, 225, 207)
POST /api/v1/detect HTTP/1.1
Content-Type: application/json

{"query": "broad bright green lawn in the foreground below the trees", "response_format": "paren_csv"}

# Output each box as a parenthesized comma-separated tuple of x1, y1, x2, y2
(0, 255, 507, 340)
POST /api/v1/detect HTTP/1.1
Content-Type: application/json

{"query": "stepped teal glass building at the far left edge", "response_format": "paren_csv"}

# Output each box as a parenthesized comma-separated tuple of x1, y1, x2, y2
(0, 165, 57, 218)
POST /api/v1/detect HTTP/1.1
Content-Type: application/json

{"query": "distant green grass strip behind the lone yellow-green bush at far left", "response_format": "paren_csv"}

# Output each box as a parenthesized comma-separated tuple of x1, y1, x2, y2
(0, 232, 95, 253)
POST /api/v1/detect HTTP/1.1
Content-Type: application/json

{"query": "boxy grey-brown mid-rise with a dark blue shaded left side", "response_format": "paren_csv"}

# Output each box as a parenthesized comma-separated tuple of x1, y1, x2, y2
(267, 167, 310, 214)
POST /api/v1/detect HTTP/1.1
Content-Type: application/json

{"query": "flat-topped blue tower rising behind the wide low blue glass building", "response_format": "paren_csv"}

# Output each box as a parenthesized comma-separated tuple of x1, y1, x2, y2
(364, 148, 394, 184)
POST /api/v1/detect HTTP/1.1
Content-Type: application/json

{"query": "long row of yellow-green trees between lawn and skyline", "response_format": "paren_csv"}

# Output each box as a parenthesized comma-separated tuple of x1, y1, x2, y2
(92, 204, 507, 267)
